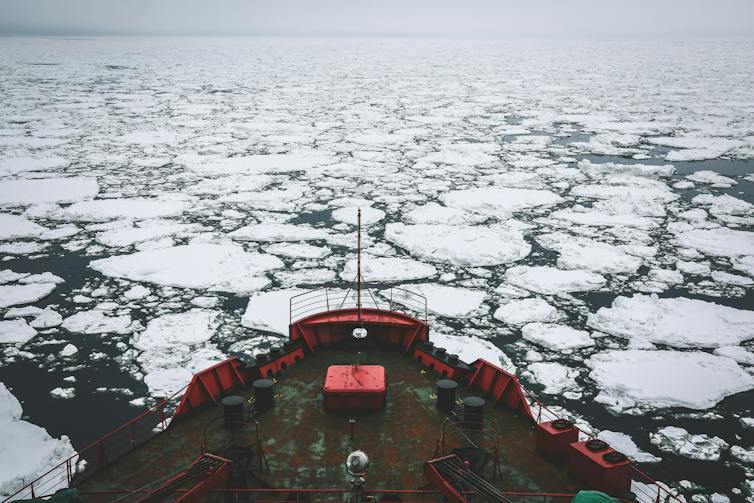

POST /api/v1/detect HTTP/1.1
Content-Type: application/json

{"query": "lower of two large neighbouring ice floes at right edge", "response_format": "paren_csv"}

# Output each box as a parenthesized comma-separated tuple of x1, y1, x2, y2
(586, 349, 754, 412)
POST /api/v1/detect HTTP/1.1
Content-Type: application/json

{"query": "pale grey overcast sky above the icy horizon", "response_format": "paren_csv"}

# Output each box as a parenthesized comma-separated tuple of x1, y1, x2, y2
(0, 0, 754, 37)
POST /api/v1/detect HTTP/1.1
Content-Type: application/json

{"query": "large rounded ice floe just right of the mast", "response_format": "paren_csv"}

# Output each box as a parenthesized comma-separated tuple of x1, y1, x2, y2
(385, 223, 531, 267)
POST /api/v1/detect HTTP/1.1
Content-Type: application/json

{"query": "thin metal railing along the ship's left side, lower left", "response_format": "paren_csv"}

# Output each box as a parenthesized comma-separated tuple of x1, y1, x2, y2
(0, 386, 188, 503)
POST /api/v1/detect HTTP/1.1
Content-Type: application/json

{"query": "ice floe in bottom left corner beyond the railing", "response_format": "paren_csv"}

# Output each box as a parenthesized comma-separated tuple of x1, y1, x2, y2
(0, 383, 76, 497)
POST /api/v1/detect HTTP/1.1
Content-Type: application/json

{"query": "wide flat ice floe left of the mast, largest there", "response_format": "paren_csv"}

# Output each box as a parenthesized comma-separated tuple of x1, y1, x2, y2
(90, 243, 283, 293)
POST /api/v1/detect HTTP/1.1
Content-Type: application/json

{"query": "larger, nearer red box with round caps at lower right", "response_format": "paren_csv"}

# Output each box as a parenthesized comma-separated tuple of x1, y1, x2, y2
(568, 439, 631, 496)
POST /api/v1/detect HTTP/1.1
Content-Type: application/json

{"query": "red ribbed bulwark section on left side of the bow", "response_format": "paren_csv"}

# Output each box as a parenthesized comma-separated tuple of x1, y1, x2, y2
(173, 357, 246, 419)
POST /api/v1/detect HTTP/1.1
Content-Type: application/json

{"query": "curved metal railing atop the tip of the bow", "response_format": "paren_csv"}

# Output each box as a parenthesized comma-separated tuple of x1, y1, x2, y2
(289, 286, 427, 324)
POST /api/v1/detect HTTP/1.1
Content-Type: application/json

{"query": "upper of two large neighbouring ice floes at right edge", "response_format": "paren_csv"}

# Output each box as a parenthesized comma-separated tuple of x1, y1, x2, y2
(587, 295, 754, 348)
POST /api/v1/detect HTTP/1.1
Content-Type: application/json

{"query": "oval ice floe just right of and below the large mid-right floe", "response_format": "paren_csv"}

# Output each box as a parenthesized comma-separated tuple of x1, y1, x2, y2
(505, 266, 606, 295)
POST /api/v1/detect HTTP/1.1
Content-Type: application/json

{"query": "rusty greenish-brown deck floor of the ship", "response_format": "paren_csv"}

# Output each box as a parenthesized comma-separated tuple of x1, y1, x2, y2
(79, 347, 580, 500)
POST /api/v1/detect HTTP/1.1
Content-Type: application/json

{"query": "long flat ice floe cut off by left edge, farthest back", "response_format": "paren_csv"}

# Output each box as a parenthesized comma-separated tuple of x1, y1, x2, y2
(0, 176, 99, 206)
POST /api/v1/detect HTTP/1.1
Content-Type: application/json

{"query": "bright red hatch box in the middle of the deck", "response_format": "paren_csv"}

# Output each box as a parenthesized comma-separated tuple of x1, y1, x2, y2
(322, 365, 387, 410)
